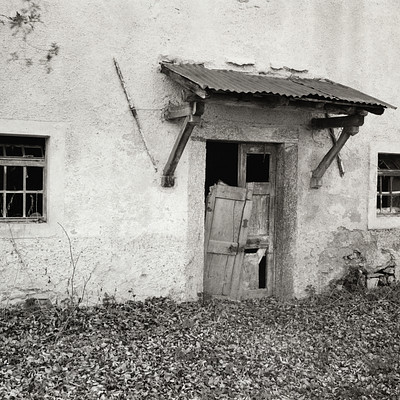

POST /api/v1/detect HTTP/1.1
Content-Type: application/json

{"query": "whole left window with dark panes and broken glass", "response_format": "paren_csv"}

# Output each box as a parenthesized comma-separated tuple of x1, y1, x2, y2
(0, 136, 46, 222)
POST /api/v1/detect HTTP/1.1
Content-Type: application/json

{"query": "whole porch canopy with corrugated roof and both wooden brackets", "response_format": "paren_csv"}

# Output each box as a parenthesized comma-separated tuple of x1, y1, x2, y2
(161, 62, 396, 187)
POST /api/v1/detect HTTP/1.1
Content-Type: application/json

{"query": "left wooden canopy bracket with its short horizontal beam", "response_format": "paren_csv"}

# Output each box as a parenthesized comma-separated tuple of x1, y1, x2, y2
(161, 103, 204, 187)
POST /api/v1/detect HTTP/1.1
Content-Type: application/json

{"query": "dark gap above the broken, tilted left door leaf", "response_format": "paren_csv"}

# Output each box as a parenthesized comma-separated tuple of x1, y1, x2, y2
(205, 141, 238, 198)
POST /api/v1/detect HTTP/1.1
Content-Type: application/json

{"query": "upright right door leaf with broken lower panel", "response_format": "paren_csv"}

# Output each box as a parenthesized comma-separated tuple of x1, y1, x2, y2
(238, 144, 276, 297)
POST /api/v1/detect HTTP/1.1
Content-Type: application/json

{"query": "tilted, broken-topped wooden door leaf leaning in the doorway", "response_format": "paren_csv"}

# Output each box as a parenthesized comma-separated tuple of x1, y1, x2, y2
(204, 183, 252, 298)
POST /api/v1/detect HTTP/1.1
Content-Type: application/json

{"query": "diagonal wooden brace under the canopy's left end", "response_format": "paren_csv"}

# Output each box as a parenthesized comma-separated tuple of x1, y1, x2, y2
(161, 103, 204, 187)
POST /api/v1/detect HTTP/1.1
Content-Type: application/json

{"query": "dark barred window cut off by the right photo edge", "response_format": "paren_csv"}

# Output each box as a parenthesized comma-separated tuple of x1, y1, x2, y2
(376, 153, 400, 215)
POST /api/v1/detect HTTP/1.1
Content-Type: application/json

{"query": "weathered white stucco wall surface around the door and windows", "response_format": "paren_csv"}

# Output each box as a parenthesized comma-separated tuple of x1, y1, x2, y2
(0, 0, 400, 302)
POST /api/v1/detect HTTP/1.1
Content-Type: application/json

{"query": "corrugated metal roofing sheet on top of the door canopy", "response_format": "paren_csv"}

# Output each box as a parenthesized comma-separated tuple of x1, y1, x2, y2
(161, 63, 396, 108)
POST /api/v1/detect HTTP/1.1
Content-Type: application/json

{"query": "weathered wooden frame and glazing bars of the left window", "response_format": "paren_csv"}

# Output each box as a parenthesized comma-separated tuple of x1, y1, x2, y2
(0, 138, 47, 224)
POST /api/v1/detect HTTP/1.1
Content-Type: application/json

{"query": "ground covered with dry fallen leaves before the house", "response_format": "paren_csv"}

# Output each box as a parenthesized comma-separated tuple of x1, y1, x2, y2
(0, 288, 400, 400)
